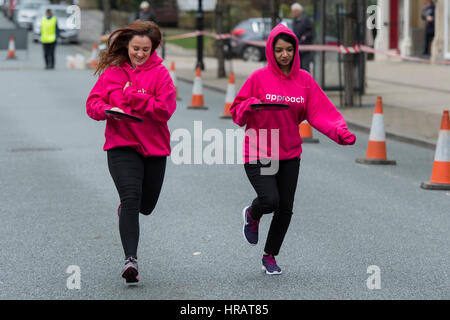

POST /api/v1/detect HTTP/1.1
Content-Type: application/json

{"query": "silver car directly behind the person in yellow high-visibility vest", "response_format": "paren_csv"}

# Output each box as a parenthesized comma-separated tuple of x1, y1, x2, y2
(33, 4, 79, 43)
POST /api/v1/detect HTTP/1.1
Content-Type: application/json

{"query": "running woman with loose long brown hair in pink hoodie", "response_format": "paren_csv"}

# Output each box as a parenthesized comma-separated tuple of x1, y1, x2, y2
(86, 21, 176, 284)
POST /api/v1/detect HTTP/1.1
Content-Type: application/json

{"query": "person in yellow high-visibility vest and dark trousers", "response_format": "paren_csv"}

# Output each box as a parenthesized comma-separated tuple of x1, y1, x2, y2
(41, 9, 59, 69)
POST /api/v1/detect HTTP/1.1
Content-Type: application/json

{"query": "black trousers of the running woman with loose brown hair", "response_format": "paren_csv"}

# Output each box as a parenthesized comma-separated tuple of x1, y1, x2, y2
(107, 147, 167, 258)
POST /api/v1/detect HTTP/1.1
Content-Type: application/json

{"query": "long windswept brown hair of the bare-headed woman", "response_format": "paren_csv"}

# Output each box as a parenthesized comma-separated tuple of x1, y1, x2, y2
(94, 20, 161, 75)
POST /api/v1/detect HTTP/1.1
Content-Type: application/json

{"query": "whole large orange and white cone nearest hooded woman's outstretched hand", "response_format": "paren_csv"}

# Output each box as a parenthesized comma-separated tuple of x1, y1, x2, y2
(356, 97, 397, 165)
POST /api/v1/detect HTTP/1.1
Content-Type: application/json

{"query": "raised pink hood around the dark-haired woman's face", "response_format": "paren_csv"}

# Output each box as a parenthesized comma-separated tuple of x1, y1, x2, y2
(266, 23, 300, 78)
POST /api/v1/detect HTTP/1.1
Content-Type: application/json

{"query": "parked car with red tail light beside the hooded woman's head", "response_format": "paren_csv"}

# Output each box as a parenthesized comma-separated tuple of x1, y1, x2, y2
(231, 18, 292, 61)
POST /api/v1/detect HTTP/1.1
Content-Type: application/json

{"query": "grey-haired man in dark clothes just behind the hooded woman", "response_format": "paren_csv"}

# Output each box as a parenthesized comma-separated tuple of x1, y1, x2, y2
(291, 2, 313, 72)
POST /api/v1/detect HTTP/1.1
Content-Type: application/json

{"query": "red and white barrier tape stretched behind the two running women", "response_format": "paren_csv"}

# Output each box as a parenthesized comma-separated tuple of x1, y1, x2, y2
(165, 31, 450, 65)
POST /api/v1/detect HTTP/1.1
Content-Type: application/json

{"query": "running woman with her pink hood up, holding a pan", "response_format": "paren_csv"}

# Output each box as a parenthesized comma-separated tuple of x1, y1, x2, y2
(230, 24, 356, 274)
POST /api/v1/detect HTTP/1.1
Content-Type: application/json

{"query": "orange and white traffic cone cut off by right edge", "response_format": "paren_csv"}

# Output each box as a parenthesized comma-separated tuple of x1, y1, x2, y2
(420, 110, 450, 190)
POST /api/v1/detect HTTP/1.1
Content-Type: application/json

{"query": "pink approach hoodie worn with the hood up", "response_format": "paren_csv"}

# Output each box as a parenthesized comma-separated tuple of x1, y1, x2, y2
(230, 24, 356, 163)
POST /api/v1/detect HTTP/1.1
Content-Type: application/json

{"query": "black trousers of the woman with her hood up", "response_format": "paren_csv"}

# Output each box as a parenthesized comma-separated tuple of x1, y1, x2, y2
(244, 158, 300, 256)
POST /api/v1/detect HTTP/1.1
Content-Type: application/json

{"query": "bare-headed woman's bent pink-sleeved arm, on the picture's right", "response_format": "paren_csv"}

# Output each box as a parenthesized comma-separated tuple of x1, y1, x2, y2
(124, 69, 177, 122)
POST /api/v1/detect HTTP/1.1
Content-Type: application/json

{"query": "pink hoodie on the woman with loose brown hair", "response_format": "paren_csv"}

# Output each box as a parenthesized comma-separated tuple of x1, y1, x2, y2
(86, 51, 176, 157)
